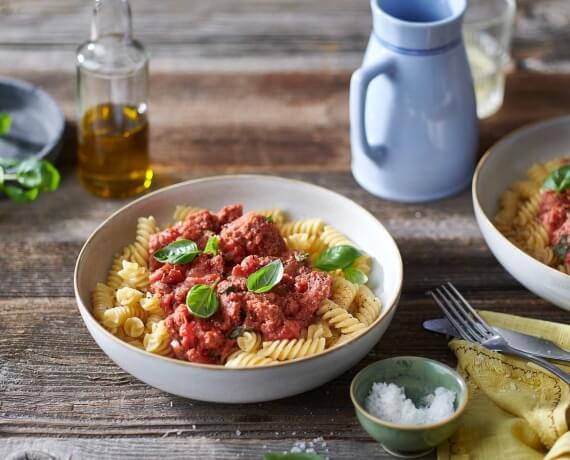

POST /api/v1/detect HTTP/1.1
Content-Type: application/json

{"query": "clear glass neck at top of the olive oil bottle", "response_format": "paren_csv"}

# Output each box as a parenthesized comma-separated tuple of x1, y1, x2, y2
(91, 0, 133, 43)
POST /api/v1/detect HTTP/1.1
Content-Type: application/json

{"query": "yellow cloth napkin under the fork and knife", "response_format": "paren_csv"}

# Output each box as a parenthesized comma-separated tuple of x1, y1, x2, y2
(438, 311, 570, 460)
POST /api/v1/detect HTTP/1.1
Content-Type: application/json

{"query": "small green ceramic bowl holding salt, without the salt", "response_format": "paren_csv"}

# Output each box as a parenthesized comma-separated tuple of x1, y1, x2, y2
(350, 356, 468, 458)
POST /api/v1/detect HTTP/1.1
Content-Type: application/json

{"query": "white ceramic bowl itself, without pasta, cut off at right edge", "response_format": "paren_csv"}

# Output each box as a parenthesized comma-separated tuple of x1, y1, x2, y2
(472, 117, 570, 310)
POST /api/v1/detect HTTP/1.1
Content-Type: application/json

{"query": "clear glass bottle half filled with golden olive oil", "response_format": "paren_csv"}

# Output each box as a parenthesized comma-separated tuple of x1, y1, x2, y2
(77, 0, 152, 198)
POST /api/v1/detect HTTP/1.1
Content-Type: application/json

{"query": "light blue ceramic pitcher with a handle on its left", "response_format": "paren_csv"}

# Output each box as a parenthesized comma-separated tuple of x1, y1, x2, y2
(350, 0, 478, 202)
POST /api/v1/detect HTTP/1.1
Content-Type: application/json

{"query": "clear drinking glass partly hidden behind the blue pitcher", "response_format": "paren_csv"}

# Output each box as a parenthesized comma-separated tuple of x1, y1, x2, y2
(463, 0, 516, 118)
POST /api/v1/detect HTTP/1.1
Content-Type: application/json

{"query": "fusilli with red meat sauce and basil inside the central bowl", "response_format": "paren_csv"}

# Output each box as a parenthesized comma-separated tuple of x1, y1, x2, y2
(93, 204, 381, 367)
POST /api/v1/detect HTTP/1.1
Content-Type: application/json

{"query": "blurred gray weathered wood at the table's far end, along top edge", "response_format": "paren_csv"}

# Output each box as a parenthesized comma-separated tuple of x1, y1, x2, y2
(0, 0, 570, 73)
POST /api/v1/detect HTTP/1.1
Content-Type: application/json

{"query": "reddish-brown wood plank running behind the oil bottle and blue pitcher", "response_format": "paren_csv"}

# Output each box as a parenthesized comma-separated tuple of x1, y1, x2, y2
(0, 71, 570, 176)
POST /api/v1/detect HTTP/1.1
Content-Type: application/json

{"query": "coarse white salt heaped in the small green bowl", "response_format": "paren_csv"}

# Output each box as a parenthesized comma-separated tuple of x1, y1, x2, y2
(365, 382, 457, 425)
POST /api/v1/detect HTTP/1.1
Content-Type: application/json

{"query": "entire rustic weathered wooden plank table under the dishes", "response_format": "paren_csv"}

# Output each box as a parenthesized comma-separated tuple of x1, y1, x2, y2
(0, 0, 570, 459)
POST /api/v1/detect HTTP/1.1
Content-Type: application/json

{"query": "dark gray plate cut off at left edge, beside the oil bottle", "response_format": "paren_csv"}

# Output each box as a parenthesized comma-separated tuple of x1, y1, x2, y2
(0, 78, 65, 161)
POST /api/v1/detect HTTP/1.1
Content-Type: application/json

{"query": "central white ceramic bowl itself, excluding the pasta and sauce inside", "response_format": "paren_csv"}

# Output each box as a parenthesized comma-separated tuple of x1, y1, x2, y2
(74, 175, 403, 403)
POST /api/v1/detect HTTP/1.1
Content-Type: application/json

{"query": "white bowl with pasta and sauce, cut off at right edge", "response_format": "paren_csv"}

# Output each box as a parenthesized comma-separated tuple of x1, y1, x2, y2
(472, 117, 570, 310)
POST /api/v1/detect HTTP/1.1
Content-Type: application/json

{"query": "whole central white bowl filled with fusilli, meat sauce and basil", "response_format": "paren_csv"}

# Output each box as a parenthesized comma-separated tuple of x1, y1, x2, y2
(74, 175, 403, 403)
